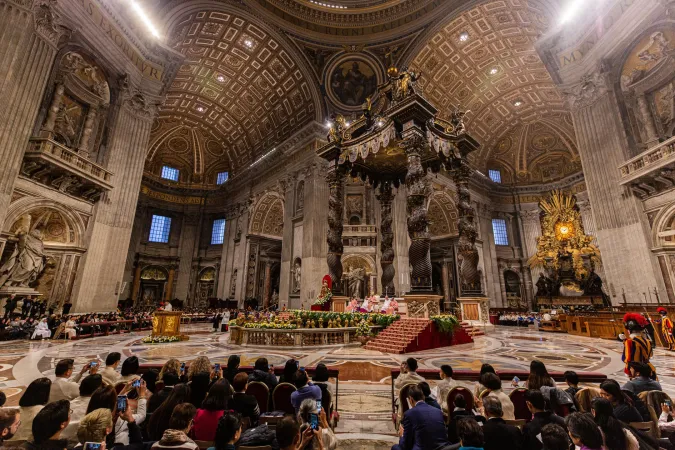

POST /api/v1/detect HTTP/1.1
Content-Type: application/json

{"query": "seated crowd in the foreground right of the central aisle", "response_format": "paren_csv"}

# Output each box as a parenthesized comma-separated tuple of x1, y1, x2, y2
(392, 358, 675, 450)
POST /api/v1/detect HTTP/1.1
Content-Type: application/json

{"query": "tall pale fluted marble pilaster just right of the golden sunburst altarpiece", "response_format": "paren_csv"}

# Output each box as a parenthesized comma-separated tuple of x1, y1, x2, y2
(568, 72, 665, 302)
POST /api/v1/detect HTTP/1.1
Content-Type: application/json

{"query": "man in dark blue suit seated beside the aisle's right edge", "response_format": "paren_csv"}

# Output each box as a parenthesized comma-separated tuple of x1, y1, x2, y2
(391, 386, 450, 450)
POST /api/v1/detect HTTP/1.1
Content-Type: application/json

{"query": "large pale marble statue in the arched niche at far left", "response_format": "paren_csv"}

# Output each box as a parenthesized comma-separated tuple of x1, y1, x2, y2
(0, 216, 47, 287)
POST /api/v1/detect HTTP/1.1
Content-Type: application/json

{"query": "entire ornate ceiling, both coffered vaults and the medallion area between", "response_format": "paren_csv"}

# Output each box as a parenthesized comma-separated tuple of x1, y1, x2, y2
(146, 0, 581, 188)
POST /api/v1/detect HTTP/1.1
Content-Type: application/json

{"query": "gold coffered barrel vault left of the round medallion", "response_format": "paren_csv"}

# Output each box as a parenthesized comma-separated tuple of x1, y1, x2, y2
(146, 5, 322, 184)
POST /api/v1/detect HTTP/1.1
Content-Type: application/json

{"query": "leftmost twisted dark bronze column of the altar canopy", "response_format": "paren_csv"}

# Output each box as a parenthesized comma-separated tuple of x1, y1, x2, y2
(326, 163, 345, 295)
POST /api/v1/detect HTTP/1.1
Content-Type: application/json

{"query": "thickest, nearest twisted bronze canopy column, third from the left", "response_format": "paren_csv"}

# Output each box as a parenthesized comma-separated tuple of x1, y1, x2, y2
(402, 130, 432, 292)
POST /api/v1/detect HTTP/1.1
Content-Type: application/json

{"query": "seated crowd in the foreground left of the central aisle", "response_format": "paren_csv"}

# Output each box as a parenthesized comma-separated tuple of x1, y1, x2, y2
(0, 352, 338, 450)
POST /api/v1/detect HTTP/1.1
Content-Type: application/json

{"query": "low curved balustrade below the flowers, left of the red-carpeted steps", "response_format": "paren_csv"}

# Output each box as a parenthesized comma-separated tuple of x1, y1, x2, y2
(230, 326, 382, 347)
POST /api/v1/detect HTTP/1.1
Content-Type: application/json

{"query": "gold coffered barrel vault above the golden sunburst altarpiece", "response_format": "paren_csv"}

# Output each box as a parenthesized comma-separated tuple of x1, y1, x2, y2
(411, 0, 581, 184)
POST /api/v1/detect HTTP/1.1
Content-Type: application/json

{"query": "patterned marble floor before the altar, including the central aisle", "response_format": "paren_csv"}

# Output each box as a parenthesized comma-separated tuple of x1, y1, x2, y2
(0, 325, 675, 448)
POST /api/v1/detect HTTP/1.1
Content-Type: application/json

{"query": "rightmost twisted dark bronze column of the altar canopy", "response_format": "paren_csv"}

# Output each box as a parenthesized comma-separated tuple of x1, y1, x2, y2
(453, 160, 483, 296)
